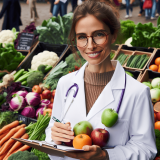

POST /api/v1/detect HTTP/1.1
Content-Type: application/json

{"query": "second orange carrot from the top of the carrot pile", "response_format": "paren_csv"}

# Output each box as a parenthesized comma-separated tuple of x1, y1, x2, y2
(0, 124, 26, 146)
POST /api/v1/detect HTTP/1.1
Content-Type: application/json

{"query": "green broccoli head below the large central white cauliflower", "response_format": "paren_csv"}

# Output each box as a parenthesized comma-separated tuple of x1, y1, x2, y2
(27, 71, 44, 88)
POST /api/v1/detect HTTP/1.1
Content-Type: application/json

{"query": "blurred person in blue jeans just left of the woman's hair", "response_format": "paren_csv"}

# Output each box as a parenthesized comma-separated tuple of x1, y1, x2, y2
(53, 0, 68, 17)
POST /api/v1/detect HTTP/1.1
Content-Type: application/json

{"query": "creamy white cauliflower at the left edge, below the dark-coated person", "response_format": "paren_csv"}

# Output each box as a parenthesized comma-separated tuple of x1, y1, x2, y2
(0, 30, 14, 47)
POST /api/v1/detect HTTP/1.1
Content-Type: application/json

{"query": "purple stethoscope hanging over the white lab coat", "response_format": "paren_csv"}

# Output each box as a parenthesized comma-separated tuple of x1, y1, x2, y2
(61, 73, 126, 122)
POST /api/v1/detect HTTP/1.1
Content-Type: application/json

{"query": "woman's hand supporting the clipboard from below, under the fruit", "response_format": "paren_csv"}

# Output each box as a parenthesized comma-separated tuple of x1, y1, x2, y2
(65, 145, 109, 160)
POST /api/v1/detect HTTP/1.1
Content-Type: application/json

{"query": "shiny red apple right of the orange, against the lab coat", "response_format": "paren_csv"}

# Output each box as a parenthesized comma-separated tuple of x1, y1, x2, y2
(91, 128, 109, 147)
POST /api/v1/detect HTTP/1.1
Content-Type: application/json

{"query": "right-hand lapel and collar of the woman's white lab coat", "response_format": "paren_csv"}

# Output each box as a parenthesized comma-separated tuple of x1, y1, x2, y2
(86, 61, 125, 121)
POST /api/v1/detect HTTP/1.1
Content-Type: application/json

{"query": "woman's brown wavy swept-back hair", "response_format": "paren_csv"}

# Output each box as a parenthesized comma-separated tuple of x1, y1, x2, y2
(68, 0, 120, 53)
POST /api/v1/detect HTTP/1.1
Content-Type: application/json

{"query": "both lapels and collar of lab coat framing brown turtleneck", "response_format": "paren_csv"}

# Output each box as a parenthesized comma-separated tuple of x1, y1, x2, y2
(73, 61, 125, 121)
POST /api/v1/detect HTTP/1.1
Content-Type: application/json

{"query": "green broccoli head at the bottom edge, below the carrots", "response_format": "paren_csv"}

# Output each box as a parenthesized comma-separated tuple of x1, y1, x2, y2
(8, 151, 38, 160)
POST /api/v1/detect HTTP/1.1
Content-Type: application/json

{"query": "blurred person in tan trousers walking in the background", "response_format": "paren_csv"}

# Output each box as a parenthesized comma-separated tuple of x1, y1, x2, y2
(27, 0, 39, 22)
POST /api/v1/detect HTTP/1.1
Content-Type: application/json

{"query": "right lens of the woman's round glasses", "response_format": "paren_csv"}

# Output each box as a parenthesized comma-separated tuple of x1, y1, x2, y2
(93, 31, 107, 44)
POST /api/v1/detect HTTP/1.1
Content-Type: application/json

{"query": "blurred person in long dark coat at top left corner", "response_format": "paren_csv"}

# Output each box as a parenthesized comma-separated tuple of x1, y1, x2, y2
(0, 0, 22, 31)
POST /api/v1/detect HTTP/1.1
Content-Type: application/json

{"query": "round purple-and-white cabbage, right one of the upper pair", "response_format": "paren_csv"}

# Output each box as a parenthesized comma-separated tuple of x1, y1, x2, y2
(25, 92, 41, 107)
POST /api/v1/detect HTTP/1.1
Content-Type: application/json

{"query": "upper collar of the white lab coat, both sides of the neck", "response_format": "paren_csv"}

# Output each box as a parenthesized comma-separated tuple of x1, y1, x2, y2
(73, 61, 125, 89)
